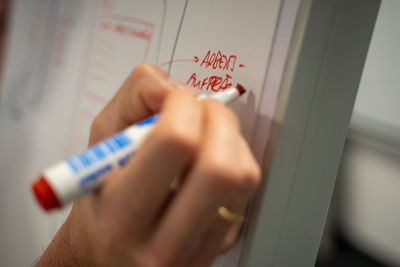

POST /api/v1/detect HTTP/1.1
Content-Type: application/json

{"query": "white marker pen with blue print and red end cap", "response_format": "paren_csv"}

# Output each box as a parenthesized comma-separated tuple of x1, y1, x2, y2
(32, 84, 246, 211)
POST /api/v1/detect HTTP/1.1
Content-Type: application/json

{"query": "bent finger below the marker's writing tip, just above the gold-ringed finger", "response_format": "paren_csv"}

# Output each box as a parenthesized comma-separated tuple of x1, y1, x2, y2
(154, 100, 257, 265)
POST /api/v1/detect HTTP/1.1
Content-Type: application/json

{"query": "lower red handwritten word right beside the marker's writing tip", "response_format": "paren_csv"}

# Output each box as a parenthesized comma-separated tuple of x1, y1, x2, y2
(186, 73, 232, 92)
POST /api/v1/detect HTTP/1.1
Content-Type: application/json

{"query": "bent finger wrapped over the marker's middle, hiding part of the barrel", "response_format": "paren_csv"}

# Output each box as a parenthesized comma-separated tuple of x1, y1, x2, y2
(98, 91, 202, 234)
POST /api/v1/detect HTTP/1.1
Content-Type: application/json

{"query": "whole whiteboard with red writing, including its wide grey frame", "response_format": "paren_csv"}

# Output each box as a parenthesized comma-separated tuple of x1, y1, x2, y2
(0, 0, 379, 267)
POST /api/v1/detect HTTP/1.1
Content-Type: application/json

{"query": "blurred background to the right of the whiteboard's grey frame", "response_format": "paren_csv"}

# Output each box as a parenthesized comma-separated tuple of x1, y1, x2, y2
(316, 0, 400, 267)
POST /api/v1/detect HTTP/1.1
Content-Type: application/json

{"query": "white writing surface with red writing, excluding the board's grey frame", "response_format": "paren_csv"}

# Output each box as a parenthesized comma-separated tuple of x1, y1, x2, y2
(0, 0, 290, 266)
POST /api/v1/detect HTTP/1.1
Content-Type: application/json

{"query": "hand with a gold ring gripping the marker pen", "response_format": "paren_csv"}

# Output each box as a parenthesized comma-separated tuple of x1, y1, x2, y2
(39, 64, 260, 266)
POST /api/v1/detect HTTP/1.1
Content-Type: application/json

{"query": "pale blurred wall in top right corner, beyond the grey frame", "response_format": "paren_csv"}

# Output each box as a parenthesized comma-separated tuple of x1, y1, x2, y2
(354, 0, 400, 126)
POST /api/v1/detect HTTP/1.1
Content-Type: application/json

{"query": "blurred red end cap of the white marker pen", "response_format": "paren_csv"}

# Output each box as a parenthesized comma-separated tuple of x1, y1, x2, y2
(32, 175, 61, 211)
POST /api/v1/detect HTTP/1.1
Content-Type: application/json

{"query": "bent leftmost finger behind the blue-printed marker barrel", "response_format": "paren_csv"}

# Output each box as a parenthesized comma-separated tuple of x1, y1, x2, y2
(89, 64, 175, 144)
